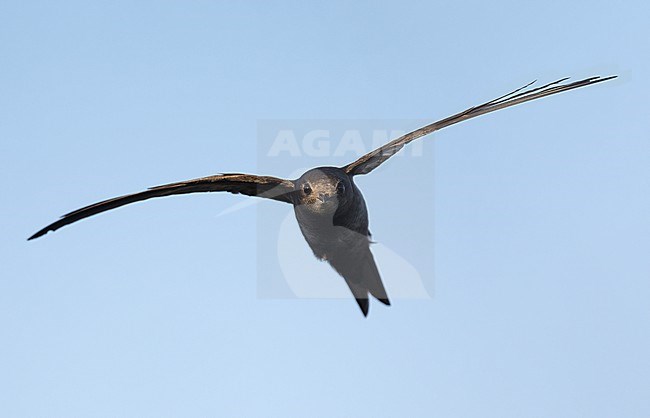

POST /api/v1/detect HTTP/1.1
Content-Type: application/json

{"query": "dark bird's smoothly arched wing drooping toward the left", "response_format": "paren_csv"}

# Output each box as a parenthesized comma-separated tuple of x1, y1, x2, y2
(28, 173, 294, 240)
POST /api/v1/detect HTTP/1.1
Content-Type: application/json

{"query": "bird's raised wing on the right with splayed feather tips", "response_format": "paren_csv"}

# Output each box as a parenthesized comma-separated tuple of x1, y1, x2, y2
(341, 76, 616, 176)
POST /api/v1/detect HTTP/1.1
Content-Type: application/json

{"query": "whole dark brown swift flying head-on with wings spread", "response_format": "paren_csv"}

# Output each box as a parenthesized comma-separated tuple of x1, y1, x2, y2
(29, 76, 616, 316)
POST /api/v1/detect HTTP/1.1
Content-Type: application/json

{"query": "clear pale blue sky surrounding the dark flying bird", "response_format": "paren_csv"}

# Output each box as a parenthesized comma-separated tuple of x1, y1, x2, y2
(0, 1, 650, 417)
